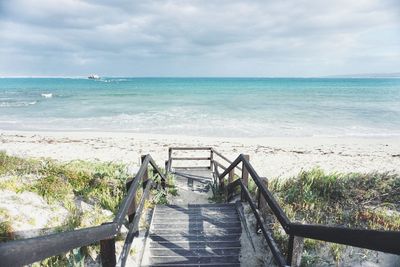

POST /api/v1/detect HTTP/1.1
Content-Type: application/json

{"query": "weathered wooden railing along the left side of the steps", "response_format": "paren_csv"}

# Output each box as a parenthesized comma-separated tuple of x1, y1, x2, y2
(0, 155, 166, 267)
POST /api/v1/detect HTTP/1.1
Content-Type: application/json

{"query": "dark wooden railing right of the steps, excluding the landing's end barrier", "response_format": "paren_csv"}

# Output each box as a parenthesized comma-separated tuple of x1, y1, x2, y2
(214, 154, 400, 266)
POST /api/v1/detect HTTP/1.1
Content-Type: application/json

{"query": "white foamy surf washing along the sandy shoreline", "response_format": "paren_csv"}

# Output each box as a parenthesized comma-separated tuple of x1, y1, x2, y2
(0, 111, 400, 137)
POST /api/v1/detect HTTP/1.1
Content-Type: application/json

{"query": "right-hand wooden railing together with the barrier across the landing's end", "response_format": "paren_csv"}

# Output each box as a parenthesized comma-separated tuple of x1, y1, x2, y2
(166, 147, 400, 266)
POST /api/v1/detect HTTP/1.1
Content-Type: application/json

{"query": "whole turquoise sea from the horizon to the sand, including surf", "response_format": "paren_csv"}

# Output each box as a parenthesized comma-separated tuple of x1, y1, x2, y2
(0, 78, 400, 137)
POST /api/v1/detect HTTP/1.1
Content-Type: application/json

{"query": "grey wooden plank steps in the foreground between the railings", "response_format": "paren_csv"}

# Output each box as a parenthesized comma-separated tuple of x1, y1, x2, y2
(142, 204, 242, 266)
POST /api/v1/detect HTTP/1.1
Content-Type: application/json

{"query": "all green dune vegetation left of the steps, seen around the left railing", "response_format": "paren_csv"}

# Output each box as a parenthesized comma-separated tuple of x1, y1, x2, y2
(0, 151, 178, 266)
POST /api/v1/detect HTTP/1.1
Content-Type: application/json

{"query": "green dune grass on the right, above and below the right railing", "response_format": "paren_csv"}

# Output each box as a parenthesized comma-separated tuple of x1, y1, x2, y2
(269, 168, 400, 266)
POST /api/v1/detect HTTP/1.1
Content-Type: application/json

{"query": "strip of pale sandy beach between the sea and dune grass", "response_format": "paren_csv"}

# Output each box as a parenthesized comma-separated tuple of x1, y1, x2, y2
(0, 131, 400, 178)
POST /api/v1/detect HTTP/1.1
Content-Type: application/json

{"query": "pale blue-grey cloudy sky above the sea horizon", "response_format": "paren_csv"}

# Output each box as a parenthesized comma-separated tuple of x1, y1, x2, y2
(0, 0, 400, 77)
